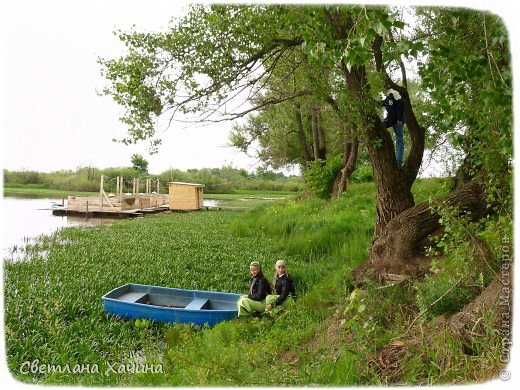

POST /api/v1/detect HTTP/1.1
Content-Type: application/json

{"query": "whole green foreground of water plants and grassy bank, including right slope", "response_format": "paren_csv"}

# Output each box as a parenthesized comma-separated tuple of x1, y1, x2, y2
(4, 180, 508, 386)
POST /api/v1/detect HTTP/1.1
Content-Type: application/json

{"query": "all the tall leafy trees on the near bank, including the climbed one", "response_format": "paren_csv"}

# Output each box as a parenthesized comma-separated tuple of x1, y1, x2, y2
(100, 5, 512, 282)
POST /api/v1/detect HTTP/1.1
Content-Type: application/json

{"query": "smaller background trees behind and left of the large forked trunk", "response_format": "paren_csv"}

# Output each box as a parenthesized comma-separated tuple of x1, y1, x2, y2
(231, 45, 359, 197)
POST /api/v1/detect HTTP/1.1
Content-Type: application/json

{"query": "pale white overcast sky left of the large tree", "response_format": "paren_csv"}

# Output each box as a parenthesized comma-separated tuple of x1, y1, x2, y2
(0, 0, 518, 173)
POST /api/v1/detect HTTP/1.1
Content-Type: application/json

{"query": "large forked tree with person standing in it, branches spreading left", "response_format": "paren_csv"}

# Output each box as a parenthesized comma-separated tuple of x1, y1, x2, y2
(101, 5, 510, 275)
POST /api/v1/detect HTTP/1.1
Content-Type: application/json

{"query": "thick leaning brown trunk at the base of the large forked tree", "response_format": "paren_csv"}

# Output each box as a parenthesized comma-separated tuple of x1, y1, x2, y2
(354, 180, 488, 282)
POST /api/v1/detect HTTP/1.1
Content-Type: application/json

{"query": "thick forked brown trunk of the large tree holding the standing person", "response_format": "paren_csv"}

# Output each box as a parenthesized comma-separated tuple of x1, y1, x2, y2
(326, 10, 448, 274)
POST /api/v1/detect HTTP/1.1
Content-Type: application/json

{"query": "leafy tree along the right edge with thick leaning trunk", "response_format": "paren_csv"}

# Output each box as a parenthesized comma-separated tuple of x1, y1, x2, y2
(364, 9, 512, 278)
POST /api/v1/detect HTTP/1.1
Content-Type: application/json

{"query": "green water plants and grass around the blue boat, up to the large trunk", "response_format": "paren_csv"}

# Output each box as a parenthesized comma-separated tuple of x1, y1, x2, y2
(4, 186, 374, 385)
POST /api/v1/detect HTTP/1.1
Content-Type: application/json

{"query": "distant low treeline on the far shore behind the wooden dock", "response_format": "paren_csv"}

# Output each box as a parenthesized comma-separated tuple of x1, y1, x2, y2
(3, 165, 303, 193)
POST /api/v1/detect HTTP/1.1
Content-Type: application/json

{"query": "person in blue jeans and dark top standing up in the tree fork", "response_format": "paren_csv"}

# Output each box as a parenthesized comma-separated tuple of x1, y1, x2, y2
(381, 89, 406, 169)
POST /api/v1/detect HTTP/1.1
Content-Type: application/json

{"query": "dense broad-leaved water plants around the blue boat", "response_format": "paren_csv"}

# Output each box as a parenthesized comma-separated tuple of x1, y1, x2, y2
(4, 212, 288, 384)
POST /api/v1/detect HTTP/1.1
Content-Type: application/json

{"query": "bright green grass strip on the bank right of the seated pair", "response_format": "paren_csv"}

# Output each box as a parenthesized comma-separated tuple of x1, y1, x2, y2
(146, 184, 375, 386)
